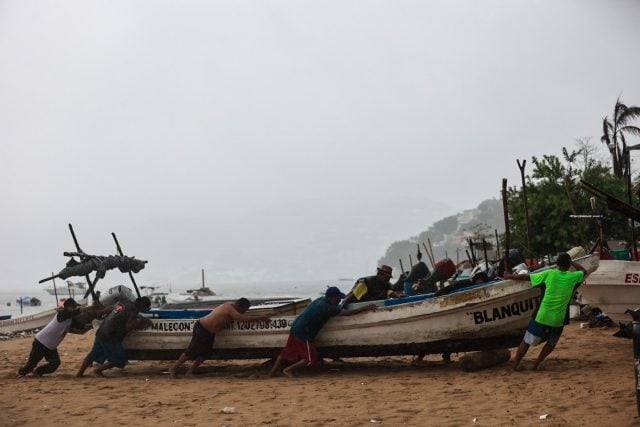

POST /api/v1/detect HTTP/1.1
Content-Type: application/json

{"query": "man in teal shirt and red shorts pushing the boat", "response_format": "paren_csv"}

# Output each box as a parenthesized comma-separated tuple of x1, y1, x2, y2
(269, 286, 376, 377)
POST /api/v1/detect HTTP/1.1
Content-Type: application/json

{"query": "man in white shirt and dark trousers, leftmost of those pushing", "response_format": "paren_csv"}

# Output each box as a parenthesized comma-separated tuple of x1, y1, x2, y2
(18, 298, 80, 377)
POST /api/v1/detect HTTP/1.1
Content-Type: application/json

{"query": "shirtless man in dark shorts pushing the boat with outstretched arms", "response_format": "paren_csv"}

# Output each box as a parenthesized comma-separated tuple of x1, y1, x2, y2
(169, 298, 270, 378)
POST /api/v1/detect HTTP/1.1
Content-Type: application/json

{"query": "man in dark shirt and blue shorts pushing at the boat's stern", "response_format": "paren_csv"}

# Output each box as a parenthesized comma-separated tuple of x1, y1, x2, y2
(76, 297, 151, 377)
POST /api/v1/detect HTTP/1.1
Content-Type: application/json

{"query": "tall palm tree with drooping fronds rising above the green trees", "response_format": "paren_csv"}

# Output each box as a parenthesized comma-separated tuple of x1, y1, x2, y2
(600, 98, 640, 177)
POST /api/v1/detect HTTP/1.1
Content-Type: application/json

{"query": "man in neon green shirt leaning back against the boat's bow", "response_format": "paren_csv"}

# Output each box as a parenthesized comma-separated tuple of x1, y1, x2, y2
(504, 253, 587, 371)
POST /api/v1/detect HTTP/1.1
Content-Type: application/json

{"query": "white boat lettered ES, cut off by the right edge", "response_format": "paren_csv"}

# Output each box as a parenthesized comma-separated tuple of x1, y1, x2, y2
(578, 259, 640, 323)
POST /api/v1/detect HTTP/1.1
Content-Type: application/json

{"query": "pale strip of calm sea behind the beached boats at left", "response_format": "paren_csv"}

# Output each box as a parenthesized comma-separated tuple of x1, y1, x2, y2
(0, 280, 353, 318)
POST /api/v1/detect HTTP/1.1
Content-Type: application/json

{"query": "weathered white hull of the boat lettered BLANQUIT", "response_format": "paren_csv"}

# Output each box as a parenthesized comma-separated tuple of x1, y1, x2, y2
(124, 254, 599, 360)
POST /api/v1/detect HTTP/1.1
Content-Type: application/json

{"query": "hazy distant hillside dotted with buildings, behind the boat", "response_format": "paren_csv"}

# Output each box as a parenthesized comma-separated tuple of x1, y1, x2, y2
(379, 199, 504, 277)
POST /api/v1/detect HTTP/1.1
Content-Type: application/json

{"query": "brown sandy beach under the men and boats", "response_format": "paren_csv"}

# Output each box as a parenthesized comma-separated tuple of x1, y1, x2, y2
(0, 323, 640, 426)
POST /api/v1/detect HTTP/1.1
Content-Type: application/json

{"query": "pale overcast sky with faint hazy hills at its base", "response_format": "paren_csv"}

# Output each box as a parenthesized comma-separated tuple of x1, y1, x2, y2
(0, 0, 640, 288)
